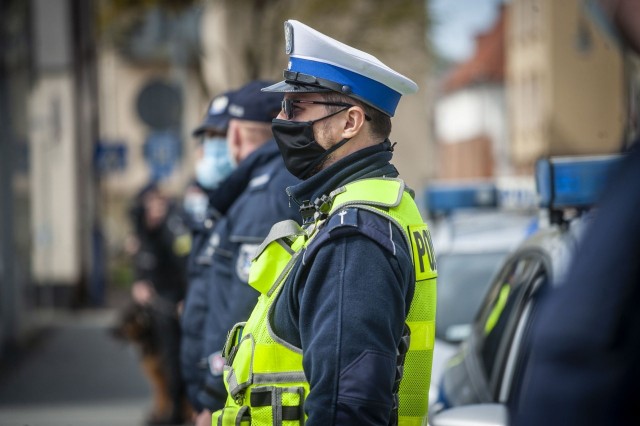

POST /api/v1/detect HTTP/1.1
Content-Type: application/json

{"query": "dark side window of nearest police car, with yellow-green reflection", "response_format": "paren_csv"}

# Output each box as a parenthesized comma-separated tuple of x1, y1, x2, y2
(475, 255, 540, 389)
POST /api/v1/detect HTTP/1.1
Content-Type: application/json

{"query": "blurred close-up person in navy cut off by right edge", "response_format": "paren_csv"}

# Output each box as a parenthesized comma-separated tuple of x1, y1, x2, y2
(510, 0, 640, 426)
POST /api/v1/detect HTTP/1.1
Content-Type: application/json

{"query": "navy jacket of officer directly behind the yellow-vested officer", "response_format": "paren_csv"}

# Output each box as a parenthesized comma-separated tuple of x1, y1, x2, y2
(183, 141, 300, 409)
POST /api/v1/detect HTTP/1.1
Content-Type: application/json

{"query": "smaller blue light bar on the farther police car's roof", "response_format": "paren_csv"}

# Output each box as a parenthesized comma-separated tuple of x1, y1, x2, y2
(425, 183, 498, 214)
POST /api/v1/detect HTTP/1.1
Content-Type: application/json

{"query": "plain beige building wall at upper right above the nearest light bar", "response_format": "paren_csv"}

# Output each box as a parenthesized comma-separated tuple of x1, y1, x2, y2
(548, 1, 626, 155)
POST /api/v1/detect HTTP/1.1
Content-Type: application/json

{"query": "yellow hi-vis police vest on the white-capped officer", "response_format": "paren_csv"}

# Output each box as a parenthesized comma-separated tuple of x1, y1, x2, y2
(212, 178, 437, 426)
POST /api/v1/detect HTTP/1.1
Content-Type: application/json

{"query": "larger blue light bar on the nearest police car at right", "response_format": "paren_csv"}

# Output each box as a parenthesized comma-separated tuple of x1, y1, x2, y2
(536, 154, 622, 209)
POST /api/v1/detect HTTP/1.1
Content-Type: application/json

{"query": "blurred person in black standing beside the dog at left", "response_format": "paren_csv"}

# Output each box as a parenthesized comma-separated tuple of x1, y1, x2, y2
(130, 182, 191, 424)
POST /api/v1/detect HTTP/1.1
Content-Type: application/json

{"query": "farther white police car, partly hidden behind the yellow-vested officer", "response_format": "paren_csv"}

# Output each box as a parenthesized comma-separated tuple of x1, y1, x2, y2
(425, 182, 537, 403)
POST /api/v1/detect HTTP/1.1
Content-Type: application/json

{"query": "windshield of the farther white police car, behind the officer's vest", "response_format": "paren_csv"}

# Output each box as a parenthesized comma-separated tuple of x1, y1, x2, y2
(436, 252, 507, 341)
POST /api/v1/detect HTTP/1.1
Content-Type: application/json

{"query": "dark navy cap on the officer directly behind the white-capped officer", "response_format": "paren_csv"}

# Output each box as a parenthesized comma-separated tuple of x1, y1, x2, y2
(227, 80, 282, 123)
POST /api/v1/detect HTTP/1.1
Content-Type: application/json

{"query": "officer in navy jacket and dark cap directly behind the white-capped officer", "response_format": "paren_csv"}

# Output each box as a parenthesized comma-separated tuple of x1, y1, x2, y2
(182, 81, 298, 425)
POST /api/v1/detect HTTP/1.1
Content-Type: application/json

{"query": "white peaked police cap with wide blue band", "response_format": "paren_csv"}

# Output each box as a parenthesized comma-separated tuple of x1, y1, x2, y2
(262, 19, 418, 117)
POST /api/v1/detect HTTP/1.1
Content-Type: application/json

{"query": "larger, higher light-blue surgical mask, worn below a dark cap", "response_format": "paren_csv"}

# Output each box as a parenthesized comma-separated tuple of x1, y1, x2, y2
(196, 137, 235, 189)
